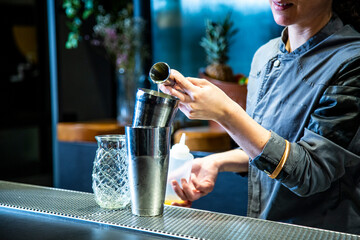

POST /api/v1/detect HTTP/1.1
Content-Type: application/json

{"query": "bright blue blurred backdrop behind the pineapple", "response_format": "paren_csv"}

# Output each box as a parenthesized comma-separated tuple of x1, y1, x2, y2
(151, 0, 281, 76)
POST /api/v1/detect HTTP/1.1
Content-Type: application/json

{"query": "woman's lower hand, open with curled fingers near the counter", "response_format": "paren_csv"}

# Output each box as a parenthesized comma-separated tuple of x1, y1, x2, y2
(172, 156, 219, 207)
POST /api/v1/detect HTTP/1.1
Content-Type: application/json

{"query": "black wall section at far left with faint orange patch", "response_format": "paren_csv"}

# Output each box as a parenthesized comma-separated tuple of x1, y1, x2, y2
(0, 0, 52, 184)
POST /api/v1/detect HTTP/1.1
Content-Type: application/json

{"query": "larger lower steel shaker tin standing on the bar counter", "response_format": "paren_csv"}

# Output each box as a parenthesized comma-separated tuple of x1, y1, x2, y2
(125, 126, 170, 216)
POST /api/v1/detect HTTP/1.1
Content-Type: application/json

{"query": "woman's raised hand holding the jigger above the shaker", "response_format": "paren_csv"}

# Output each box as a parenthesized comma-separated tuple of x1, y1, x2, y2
(160, 69, 232, 121)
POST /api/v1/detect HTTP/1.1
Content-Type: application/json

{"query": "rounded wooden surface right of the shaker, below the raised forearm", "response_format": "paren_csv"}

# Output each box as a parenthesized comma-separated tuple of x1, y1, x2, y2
(174, 126, 231, 152)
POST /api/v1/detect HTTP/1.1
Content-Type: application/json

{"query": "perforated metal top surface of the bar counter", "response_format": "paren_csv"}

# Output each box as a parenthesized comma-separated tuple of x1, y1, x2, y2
(0, 181, 360, 240)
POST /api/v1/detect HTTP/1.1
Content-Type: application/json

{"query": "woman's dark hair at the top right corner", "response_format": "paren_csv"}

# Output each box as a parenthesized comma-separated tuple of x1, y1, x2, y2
(332, 0, 360, 32)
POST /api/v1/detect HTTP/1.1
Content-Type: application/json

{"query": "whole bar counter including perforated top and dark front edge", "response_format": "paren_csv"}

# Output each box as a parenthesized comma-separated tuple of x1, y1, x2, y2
(0, 181, 360, 240)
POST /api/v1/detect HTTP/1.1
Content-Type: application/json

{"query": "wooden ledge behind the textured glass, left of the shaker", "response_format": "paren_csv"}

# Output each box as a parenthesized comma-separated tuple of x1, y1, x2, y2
(57, 120, 125, 142)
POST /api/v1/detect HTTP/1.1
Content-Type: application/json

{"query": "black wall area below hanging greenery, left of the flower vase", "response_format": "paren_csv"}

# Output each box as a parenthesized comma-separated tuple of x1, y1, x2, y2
(56, 0, 116, 122)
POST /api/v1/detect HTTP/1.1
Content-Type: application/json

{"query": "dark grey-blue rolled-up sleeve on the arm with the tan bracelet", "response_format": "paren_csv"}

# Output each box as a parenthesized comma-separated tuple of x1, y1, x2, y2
(250, 59, 360, 196)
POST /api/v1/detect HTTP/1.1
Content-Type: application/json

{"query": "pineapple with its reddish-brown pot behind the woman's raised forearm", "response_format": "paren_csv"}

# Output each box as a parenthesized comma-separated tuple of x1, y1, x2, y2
(199, 13, 248, 128)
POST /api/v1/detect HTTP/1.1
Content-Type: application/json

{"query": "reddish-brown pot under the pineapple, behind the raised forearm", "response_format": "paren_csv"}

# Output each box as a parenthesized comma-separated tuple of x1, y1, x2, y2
(199, 68, 247, 129)
